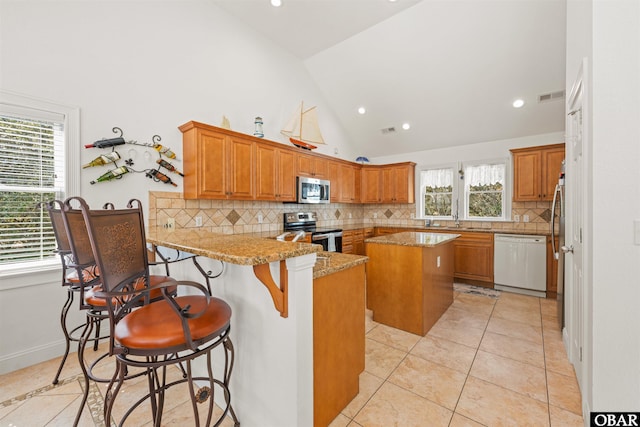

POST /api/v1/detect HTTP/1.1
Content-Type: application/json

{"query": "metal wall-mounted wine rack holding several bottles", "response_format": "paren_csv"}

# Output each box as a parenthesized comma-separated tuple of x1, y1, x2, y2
(82, 127, 184, 187)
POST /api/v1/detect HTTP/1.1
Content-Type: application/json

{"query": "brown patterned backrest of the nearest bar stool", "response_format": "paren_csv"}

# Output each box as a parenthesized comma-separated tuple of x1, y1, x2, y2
(76, 198, 150, 292)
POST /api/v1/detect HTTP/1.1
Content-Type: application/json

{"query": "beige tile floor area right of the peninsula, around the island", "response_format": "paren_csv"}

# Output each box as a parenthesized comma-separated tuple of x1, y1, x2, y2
(330, 292, 584, 427)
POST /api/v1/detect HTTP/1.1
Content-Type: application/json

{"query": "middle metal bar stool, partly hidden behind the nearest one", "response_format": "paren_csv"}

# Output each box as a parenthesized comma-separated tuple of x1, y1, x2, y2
(60, 197, 177, 425)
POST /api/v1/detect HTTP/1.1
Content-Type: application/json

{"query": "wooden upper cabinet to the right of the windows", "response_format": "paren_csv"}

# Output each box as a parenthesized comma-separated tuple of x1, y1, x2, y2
(511, 144, 565, 202)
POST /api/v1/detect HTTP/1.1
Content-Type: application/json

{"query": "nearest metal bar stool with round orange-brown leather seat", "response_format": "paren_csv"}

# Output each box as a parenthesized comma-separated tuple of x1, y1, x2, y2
(79, 200, 240, 426)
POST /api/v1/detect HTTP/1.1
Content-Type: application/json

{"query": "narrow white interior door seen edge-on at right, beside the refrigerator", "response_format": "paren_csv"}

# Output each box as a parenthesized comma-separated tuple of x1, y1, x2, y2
(561, 60, 589, 390)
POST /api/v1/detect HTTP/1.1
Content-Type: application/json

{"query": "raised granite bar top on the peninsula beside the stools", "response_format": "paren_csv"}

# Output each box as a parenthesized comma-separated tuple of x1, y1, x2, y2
(147, 227, 322, 265)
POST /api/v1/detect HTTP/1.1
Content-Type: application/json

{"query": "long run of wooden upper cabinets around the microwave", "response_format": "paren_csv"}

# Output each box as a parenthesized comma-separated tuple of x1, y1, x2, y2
(180, 121, 415, 203)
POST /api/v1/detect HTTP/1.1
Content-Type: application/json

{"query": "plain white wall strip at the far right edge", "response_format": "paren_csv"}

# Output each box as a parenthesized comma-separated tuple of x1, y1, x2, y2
(591, 0, 640, 411)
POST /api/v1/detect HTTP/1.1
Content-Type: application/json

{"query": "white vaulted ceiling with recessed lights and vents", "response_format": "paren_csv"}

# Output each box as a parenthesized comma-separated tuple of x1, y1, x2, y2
(212, 0, 566, 157)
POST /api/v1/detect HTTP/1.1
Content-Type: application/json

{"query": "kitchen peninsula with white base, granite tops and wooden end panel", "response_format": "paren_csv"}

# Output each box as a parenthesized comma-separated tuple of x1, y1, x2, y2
(147, 227, 367, 427)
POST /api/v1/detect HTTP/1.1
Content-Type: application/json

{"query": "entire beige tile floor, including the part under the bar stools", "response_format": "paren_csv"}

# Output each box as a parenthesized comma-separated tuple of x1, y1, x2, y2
(0, 292, 583, 427)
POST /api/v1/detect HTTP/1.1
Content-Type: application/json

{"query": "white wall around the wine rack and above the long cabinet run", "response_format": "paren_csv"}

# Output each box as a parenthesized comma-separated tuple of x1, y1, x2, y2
(0, 0, 353, 372)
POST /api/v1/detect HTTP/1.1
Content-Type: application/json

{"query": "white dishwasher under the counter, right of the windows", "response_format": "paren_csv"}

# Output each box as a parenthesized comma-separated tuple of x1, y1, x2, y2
(493, 234, 547, 298)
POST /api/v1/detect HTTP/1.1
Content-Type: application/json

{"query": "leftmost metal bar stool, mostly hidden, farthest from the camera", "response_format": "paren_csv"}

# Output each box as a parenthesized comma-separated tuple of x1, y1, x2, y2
(38, 200, 99, 385)
